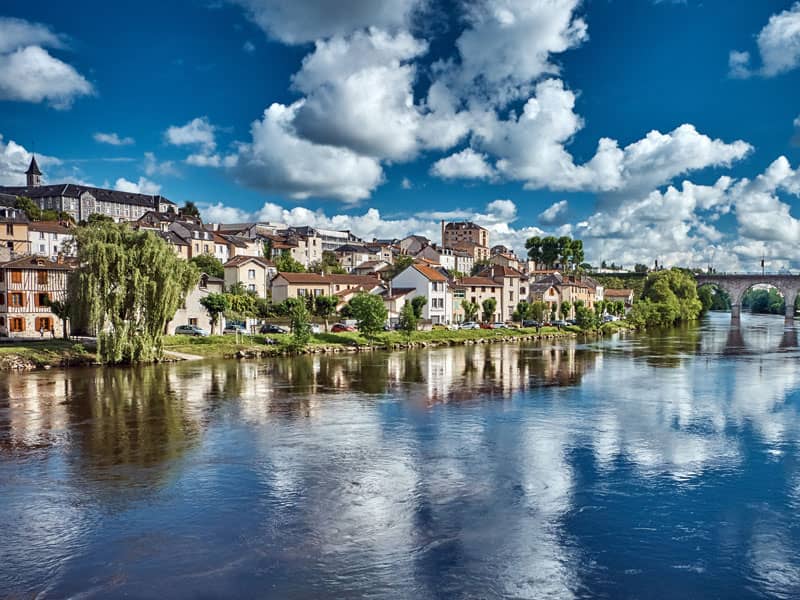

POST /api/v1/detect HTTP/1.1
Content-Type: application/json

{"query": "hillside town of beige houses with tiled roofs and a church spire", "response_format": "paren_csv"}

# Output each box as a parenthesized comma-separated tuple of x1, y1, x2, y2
(0, 157, 633, 338)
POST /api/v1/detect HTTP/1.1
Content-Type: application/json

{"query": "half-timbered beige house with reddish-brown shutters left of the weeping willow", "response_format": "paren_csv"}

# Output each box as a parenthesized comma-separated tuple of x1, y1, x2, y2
(0, 256, 73, 338)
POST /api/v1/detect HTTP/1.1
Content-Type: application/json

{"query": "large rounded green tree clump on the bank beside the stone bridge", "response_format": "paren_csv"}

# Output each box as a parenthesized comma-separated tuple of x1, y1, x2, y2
(628, 269, 703, 327)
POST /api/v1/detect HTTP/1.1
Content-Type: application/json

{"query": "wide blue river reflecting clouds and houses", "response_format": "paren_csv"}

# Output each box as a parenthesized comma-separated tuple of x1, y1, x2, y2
(0, 314, 800, 599)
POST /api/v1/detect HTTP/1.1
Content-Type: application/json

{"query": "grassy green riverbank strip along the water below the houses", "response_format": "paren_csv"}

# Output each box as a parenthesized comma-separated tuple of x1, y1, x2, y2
(0, 327, 616, 371)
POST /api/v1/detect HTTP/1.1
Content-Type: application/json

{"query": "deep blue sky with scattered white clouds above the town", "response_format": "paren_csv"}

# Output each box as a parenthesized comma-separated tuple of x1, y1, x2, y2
(0, 0, 800, 269)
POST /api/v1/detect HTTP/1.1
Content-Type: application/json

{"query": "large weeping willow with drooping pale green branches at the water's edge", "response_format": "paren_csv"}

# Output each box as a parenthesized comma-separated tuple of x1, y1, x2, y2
(69, 222, 199, 364)
